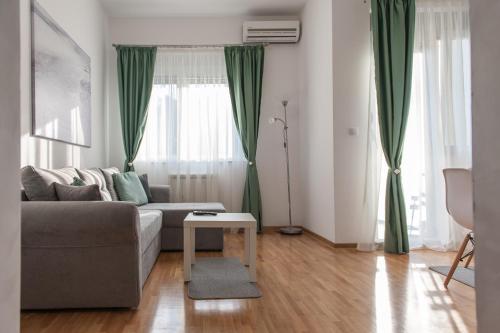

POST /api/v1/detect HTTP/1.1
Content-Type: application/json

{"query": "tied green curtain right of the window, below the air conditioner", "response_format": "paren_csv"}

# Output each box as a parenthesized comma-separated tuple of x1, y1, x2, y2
(224, 45, 264, 232)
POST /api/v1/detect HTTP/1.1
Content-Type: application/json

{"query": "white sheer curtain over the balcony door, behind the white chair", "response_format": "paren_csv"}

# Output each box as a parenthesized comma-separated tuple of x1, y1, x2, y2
(402, 0, 472, 251)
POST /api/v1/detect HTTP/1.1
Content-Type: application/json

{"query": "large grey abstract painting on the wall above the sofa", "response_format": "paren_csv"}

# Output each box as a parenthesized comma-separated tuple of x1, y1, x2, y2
(31, 0, 91, 147)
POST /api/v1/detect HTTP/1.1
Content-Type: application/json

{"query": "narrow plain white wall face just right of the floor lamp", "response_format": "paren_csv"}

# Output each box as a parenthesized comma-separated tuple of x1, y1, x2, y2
(299, 0, 335, 241)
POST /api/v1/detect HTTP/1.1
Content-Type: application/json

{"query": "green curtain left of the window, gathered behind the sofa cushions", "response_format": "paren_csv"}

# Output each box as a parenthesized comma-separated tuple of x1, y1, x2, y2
(116, 46, 156, 171)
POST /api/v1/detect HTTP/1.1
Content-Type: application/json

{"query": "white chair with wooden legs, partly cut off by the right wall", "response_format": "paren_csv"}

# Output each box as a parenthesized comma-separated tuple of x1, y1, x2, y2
(443, 169, 474, 288)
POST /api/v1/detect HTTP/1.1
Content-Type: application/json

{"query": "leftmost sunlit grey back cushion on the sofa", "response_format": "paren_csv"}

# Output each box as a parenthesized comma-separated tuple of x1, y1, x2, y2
(21, 165, 79, 201)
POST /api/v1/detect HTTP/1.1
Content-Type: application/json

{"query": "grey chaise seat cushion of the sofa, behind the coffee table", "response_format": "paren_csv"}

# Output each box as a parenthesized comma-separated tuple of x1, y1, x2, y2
(137, 202, 226, 228)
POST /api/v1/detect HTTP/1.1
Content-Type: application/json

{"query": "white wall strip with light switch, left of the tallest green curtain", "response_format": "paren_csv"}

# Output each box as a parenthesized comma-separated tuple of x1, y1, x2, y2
(333, 0, 370, 243)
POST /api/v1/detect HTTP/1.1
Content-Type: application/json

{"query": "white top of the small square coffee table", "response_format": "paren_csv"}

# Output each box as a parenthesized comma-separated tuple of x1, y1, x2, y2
(184, 213, 257, 228)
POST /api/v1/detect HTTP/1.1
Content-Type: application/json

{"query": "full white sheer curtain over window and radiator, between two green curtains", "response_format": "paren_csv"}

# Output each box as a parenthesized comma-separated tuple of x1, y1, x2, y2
(134, 47, 246, 211)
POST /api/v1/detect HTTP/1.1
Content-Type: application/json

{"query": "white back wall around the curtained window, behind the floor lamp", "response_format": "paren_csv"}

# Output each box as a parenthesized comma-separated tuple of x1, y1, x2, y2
(108, 17, 302, 226)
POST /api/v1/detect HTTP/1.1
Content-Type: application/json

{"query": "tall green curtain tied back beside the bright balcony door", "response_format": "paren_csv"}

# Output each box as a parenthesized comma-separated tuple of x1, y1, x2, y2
(371, 0, 415, 253)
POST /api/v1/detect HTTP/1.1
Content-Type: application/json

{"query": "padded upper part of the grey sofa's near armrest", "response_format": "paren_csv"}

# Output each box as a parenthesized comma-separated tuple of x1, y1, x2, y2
(21, 201, 140, 248)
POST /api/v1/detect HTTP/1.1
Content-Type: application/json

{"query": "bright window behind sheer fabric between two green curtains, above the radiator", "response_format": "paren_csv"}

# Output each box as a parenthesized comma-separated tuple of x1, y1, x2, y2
(137, 48, 241, 162)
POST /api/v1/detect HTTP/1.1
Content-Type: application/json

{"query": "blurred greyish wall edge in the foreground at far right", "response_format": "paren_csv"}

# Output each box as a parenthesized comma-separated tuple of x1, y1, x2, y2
(470, 0, 500, 333)
